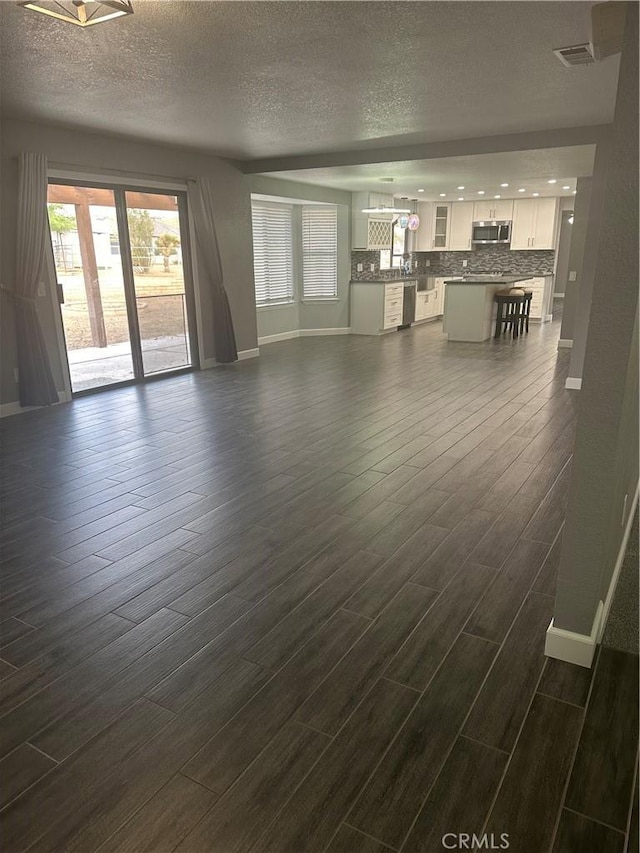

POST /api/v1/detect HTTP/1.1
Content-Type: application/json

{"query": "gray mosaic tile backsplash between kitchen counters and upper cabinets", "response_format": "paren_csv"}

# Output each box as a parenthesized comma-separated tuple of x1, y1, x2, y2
(351, 246, 555, 281)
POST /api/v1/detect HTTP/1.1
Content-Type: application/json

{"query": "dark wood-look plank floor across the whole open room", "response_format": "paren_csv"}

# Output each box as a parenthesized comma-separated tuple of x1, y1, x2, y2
(0, 314, 637, 853)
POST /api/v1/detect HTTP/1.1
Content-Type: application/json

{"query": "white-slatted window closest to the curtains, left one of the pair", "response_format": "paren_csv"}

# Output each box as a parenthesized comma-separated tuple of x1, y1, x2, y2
(251, 201, 293, 305)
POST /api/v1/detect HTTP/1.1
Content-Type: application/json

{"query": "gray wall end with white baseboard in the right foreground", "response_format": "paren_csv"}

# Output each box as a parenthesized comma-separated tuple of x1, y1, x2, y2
(546, 3, 638, 666)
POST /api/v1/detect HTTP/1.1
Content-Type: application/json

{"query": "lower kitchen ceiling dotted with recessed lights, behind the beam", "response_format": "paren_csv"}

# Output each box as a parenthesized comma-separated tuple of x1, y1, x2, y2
(271, 145, 595, 201)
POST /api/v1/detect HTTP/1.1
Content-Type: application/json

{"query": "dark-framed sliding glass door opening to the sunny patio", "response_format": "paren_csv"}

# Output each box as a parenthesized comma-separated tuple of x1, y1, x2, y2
(48, 183, 192, 393)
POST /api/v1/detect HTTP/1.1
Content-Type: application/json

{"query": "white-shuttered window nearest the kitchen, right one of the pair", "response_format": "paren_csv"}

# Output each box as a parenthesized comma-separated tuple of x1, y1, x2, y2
(302, 205, 338, 299)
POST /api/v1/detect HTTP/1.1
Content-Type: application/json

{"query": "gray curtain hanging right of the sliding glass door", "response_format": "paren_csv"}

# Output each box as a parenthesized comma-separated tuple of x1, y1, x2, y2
(189, 178, 238, 364)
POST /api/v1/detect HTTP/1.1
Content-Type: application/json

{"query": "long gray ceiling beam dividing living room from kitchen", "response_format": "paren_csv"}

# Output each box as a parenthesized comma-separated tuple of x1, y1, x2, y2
(236, 124, 611, 175)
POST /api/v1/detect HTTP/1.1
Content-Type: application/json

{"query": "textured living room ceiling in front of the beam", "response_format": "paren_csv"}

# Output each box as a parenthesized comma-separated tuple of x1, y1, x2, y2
(0, 0, 618, 159)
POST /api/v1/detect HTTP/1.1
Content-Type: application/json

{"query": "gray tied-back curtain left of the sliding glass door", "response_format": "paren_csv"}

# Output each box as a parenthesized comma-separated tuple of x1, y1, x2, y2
(11, 154, 58, 406)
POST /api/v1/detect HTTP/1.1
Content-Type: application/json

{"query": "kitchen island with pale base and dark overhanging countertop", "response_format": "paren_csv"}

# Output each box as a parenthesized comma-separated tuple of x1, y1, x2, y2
(442, 275, 531, 342)
